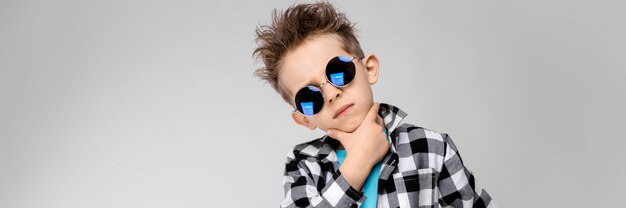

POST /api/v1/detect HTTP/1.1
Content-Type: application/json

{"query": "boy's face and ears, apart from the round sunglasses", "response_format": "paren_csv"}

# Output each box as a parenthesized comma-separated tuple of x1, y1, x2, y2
(278, 34, 378, 132)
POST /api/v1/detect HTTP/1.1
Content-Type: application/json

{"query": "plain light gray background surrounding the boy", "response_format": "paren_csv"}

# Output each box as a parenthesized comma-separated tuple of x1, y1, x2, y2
(0, 0, 626, 208)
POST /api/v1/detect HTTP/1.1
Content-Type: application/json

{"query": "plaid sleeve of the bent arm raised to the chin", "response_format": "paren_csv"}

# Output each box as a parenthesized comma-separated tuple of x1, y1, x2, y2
(280, 147, 366, 208)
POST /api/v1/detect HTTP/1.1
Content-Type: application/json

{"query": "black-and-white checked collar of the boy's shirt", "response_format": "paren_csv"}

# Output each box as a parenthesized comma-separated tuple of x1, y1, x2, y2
(301, 103, 407, 160)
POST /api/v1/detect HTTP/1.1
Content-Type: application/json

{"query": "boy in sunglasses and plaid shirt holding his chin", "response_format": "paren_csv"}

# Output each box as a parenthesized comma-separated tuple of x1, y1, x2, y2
(254, 2, 495, 207)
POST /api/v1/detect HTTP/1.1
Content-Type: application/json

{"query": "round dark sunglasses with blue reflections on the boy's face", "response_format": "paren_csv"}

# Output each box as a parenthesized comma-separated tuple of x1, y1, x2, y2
(294, 56, 362, 116)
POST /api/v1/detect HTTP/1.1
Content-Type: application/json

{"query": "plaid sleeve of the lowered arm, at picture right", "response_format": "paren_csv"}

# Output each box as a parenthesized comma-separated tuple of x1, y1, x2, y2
(437, 133, 496, 208)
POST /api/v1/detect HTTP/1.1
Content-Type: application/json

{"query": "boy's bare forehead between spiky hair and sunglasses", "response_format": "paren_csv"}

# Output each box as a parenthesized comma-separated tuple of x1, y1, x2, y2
(278, 34, 349, 96)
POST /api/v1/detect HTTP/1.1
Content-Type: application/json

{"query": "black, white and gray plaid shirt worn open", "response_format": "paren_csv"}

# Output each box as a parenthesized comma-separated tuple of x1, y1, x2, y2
(281, 103, 496, 208)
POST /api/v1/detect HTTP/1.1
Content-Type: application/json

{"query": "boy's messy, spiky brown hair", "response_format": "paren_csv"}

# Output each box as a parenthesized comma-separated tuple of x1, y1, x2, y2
(253, 2, 363, 105)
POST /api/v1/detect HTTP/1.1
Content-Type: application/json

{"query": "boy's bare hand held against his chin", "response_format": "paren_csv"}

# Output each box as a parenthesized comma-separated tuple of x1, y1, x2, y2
(327, 103, 389, 169)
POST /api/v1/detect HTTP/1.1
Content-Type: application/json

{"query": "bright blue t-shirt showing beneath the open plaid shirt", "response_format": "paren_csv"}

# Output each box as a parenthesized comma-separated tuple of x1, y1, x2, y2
(335, 129, 389, 208)
